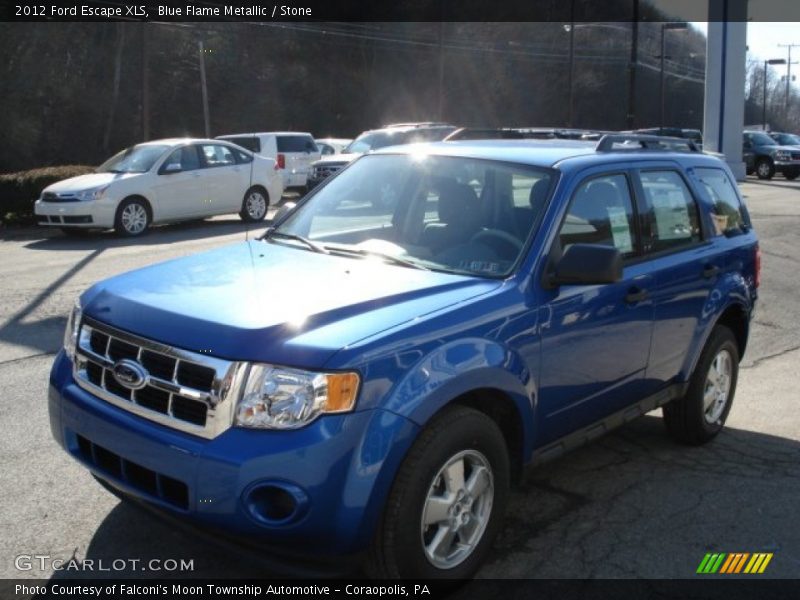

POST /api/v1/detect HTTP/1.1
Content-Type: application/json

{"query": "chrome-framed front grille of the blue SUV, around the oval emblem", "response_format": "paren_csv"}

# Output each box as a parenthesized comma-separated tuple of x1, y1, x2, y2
(74, 317, 246, 439)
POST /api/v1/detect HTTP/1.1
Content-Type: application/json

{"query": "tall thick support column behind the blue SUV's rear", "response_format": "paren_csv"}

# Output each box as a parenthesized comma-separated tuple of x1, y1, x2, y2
(703, 0, 747, 181)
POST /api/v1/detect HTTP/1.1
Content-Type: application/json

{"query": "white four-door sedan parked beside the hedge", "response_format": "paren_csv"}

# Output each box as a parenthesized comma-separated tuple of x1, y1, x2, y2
(35, 138, 283, 236)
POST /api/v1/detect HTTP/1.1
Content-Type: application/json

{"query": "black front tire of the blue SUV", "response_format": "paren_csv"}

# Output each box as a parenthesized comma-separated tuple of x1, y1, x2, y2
(366, 406, 510, 579)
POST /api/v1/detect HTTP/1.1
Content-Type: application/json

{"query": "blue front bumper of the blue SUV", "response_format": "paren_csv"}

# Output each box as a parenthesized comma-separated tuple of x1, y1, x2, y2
(49, 352, 417, 558)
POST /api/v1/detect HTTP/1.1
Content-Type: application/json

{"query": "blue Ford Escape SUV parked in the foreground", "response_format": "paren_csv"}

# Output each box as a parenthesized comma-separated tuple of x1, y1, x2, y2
(49, 135, 760, 578)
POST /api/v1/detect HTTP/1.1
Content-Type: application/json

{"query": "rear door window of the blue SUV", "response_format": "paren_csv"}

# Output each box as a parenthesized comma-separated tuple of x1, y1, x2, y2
(639, 170, 702, 252)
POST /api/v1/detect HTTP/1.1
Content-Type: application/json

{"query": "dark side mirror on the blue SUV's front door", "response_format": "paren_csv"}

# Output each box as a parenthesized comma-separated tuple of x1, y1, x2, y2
(550, 244, 622, 285)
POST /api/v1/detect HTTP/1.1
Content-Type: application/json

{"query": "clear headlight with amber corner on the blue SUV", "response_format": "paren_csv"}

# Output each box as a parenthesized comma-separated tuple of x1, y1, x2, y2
(236, 365, 359, 429)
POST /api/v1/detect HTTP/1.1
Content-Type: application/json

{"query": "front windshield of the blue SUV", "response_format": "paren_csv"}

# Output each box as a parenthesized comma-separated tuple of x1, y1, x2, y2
(268, 154, 554, 277)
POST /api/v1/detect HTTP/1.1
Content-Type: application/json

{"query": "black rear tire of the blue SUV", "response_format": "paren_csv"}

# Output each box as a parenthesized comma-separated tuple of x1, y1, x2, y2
(663, 325, 739, 446)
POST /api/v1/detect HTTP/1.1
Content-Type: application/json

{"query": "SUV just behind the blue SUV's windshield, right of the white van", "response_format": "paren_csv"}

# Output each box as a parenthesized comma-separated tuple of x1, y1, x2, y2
(308, 122, 457, 189)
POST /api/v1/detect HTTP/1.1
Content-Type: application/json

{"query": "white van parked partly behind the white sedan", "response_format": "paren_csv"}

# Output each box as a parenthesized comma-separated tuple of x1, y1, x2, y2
(217, 131, 320, 189)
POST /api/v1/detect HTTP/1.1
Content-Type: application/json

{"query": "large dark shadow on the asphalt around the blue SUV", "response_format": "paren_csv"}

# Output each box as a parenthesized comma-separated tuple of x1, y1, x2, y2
(47, 415, 800, 579)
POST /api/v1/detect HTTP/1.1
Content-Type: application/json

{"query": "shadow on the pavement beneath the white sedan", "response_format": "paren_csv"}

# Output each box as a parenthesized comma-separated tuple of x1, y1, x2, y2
(14, 217, 272, 252)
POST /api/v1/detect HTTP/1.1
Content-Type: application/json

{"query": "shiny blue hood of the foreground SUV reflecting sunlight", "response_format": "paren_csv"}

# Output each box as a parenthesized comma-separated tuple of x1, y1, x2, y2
(82, 241, 502, 368)
